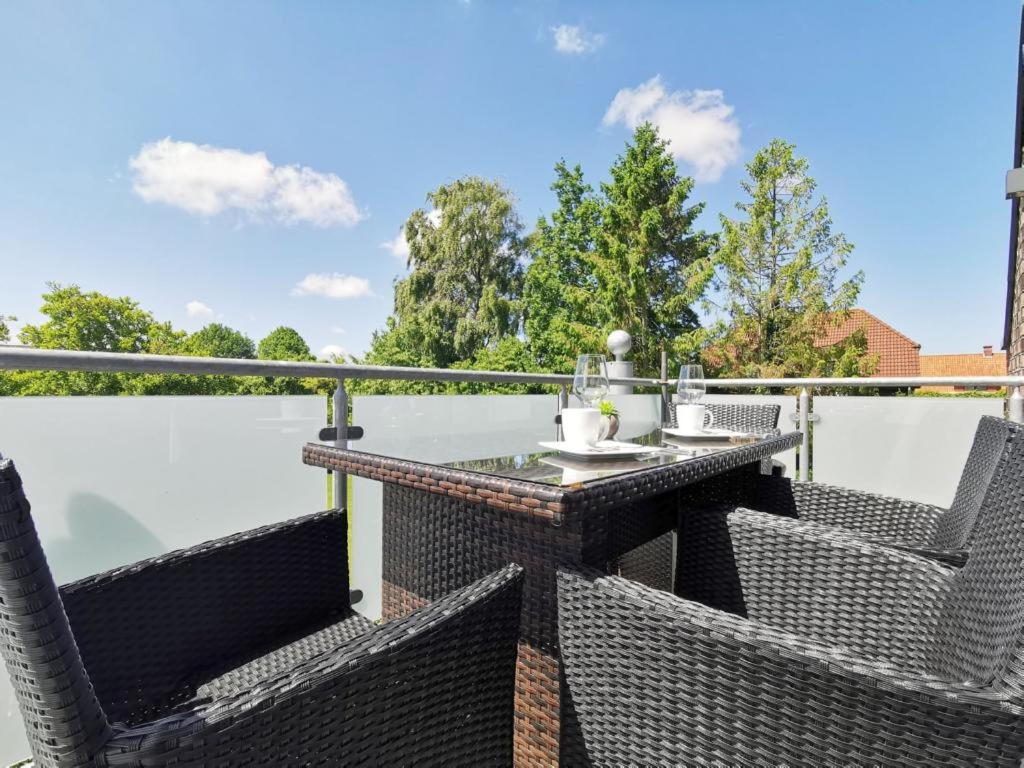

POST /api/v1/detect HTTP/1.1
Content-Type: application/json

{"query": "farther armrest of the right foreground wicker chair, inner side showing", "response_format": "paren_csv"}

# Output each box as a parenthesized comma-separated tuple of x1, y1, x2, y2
(727, 510, 954, 664)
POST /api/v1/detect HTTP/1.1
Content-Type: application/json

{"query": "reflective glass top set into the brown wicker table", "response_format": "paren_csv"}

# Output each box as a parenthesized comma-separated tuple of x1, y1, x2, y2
(441, 429, 769, 486)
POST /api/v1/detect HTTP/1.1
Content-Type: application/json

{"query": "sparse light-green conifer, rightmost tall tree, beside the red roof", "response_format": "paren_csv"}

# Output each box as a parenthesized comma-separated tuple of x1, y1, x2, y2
(712, 139, 870, 378)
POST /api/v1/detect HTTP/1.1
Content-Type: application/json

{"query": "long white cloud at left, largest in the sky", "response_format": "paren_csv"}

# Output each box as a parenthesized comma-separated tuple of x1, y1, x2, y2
(129, 137, 366, 227)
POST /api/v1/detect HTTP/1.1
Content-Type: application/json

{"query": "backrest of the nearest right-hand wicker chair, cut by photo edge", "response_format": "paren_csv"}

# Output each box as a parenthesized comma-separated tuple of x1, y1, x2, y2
(929, 423, 1024, 687)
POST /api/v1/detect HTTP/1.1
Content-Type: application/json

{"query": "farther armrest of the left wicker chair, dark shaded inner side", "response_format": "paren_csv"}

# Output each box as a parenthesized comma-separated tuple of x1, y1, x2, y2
(60, 510, 348, 722)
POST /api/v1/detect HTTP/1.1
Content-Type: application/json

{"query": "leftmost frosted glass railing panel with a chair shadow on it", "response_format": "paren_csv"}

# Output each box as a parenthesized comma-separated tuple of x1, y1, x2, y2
(0, 395, 327, 766)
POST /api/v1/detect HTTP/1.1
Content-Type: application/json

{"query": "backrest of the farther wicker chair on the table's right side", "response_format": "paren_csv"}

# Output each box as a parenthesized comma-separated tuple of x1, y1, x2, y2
(934, 416, 1013, 549)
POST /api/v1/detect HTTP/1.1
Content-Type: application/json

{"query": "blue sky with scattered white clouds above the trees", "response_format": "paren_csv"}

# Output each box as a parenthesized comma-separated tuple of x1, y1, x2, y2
(0, 0, 1020, 362)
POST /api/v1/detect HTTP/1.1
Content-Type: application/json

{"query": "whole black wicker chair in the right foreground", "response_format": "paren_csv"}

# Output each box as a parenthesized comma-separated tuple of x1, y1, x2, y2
(558, 423, 1024, 768)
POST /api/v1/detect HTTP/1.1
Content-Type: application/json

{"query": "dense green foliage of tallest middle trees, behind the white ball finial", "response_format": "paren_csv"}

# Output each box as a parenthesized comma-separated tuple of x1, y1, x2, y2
(523, 124, 714, 372)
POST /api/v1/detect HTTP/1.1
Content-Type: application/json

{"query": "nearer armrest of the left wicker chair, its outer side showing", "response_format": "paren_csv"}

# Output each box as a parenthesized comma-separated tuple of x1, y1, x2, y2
(105, 564, 523, 765)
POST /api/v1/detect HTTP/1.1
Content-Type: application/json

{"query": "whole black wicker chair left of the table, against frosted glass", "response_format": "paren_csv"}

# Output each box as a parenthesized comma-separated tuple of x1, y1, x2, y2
(0, 459, 522, 768)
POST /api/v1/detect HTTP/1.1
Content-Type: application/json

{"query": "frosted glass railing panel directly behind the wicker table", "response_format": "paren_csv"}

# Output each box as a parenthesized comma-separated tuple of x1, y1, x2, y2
(350, 394, 561, 618)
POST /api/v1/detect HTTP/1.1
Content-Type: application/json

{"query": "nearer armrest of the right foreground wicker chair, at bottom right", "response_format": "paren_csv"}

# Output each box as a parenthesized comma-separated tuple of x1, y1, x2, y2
(558, 571, 1024, 766)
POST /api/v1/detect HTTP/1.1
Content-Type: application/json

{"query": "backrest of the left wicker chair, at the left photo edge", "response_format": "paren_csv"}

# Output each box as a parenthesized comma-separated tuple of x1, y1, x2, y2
(0, 458, 111, 768)
